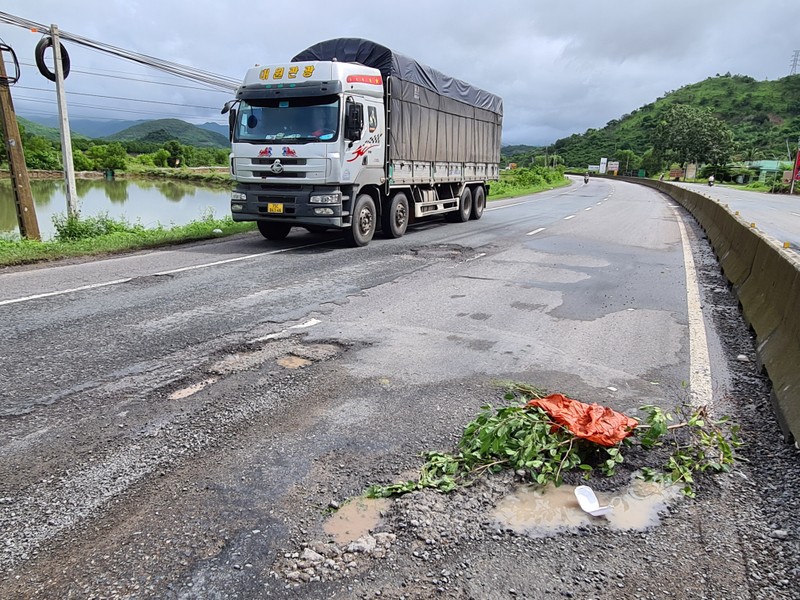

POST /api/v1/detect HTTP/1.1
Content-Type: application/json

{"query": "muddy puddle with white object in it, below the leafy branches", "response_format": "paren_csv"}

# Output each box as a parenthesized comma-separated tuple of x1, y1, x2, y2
(493, 479, 681, 537)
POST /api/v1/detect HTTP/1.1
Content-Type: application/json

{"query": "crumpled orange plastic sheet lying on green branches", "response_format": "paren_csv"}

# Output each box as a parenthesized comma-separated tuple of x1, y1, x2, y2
(528, 394, 638, 446)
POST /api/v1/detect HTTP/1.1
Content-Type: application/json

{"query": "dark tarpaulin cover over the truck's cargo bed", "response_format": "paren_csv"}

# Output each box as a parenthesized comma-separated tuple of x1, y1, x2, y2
(292, 38, 503, 163)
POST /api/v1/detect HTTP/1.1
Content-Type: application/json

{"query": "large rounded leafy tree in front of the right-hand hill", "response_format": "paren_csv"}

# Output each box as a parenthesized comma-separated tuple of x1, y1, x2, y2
(653, 104, 734, 167)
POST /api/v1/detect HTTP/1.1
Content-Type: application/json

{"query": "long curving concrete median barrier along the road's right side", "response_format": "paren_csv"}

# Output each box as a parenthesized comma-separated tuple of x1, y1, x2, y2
(614, 177, 800, 442)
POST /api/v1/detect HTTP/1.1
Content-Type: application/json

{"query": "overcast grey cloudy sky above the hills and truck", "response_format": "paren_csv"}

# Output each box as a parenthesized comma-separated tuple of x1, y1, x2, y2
(0, 0, 800, 145)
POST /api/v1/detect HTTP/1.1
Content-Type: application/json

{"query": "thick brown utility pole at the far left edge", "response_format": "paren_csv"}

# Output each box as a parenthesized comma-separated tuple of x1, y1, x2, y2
(0, 42, 42, 240)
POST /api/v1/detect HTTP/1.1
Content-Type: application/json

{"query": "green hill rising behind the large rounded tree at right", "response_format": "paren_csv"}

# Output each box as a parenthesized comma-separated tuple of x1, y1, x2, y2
(503, 74, 800, 168)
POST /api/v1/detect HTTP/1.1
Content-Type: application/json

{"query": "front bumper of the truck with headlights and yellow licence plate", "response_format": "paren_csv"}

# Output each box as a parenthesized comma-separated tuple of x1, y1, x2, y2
(231, 185, 349, 229)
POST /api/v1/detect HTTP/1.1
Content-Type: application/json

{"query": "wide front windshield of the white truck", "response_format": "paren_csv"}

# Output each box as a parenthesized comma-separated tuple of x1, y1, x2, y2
(234, 96, 339, 144)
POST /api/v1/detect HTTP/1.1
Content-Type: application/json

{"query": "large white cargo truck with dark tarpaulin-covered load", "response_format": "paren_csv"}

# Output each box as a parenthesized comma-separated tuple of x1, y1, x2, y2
(222, 38, 503, 246)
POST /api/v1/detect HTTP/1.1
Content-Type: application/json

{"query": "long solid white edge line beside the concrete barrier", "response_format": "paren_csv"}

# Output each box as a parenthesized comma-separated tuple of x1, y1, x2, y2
(675, 211, 712, 406)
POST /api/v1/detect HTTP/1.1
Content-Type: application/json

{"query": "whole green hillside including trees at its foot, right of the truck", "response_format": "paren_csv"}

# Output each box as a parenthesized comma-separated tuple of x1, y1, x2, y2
(503, 73, 800, 186)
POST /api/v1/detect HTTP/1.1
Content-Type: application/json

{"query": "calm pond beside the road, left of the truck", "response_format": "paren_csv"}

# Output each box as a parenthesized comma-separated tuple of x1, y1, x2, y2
(0, 179, 231, 240)
